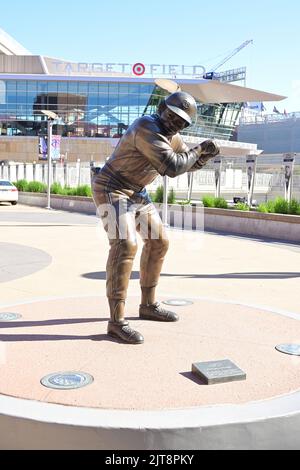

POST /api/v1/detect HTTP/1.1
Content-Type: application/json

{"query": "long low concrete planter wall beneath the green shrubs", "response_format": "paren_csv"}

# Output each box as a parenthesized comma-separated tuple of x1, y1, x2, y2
(19, 192, 300, 243)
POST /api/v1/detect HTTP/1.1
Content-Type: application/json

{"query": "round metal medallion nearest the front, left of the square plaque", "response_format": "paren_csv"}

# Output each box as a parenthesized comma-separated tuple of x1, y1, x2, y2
(41, 372, 94, 390)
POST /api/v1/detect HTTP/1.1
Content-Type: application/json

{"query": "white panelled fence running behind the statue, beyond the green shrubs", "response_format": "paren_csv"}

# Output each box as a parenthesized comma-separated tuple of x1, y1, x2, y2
(0, 159, 300, 202)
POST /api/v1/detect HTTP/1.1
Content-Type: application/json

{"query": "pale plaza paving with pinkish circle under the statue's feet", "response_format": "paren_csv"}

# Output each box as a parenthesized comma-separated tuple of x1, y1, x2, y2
(0, 204, 300, 448)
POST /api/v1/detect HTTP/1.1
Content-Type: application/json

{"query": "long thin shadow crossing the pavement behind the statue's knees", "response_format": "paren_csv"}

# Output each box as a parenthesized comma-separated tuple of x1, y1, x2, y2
(82, 271, 300, 281)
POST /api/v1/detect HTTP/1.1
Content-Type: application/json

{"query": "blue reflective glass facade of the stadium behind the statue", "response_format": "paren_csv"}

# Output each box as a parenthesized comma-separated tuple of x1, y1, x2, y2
(0, 79, 241, 140)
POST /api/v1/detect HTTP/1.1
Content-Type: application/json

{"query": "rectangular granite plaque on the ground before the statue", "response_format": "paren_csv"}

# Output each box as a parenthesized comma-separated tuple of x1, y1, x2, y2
(192, 360, 247, 385)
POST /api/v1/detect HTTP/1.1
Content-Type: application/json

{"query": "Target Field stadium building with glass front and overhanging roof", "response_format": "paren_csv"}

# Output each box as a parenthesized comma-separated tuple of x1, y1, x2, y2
(0, 30, 283, 162)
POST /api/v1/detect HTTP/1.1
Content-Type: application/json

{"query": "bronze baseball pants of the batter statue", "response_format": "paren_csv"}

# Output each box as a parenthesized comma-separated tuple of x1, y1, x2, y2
(92, 185, 169, 300)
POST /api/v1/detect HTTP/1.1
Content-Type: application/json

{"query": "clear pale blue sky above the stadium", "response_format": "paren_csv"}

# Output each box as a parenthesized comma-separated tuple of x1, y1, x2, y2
(0, 0, 300, 112)
